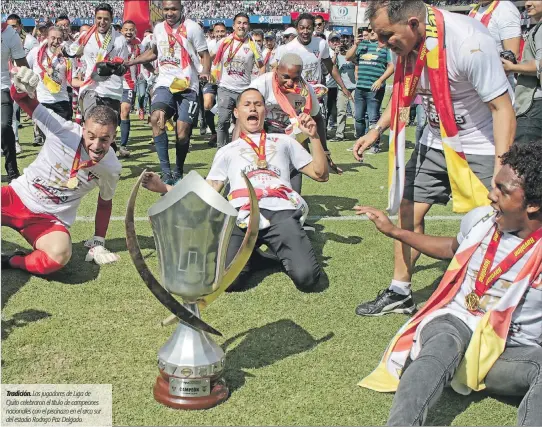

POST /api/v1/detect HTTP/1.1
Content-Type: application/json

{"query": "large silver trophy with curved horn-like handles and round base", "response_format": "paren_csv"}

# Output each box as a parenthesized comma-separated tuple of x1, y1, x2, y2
(126, 171, 259, 409)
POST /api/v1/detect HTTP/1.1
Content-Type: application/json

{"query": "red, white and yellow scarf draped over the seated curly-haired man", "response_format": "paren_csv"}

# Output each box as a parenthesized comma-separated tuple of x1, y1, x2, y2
(358, 215, 542, 394)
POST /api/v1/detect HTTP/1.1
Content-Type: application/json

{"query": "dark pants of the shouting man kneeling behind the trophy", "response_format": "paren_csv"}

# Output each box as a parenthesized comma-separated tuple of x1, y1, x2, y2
(226, 209, 321, 291)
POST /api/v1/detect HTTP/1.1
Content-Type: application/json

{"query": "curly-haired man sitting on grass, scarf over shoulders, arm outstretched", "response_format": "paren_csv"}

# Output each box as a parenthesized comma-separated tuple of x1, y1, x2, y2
(356, 140, 542, 426)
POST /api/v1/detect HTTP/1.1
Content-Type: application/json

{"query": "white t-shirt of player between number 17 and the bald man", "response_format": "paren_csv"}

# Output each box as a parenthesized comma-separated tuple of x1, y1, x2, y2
(218, 37, 261, 93)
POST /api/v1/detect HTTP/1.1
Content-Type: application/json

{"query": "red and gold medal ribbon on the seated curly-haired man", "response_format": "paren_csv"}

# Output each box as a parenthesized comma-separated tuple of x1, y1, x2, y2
(474, 228, 542, 297)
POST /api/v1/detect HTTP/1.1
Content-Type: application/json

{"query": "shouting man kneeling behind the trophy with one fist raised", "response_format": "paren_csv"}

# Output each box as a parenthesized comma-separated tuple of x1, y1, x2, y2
(143, 89, 328, 291)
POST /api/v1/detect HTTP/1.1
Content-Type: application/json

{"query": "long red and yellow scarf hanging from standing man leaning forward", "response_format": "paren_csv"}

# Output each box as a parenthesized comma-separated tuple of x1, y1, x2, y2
(387, 6, 489, 214)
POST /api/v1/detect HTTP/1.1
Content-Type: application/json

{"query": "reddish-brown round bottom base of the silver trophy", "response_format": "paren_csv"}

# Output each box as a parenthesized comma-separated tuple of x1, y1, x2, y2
(153, 375, 230, 410)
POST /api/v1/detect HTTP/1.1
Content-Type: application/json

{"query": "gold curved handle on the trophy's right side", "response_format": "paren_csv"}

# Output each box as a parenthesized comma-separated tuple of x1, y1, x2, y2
(198, 172, 260, 309)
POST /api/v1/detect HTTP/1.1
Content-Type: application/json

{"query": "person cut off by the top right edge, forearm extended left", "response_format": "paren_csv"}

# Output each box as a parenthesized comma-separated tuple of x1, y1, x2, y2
(501, 1, 542, 141)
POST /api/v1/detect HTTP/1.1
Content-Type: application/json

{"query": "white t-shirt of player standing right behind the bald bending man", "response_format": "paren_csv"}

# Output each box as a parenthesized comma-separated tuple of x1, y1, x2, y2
(275, 37, 330, 85)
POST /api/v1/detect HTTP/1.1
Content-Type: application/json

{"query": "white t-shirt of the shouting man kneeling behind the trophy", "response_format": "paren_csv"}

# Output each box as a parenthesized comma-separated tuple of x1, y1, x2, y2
(207, 133, 312, 211)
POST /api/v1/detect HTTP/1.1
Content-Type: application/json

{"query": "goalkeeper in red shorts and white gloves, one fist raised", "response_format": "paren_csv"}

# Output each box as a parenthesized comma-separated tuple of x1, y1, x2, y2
(1, 67, 121, 275)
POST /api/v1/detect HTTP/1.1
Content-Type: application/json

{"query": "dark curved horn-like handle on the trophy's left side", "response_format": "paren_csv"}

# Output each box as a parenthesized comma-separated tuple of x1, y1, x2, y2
(124, 170, 222, 336)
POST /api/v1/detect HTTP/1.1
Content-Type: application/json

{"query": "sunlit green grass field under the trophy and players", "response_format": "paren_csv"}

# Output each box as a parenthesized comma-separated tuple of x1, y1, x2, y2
(2, 112, 518, 426)
